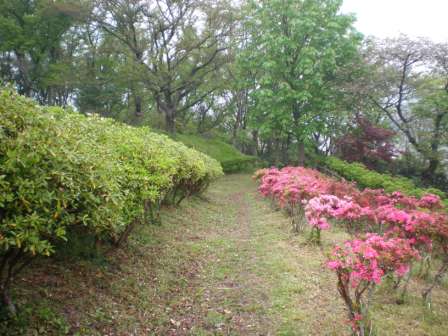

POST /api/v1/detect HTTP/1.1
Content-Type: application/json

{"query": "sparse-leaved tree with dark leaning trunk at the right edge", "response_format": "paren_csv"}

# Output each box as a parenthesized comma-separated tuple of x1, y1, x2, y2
(365, 36, 448, 182)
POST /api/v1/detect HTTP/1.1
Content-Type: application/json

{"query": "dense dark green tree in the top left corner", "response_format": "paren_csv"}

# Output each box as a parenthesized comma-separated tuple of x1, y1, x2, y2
(0, 0, 81, 105)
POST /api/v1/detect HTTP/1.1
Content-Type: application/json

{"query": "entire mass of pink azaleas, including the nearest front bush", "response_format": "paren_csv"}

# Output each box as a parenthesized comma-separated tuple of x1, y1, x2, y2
(255, 167, 448, 335)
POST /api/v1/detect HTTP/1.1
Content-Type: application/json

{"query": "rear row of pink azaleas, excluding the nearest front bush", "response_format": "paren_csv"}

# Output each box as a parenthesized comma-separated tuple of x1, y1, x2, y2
(255, 167, 447, 245)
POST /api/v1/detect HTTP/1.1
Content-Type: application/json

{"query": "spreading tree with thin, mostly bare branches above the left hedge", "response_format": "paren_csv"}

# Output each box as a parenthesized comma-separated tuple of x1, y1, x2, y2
(95, 0, 232, 133)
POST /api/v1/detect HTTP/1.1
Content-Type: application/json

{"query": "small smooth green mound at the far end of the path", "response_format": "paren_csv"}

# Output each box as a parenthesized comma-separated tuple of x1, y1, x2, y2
(175, 134, 256, 173)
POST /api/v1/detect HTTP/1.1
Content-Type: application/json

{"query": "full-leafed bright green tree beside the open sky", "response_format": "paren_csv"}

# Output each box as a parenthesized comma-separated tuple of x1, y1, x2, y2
(241, 0, 360, 164)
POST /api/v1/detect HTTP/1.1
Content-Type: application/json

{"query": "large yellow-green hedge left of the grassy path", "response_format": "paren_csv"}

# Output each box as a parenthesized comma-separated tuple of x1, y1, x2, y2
(0, 90, 222, 316)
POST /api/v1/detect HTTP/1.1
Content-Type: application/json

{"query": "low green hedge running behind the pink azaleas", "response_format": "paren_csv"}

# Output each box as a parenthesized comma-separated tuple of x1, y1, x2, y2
(324, 157, 447, 199)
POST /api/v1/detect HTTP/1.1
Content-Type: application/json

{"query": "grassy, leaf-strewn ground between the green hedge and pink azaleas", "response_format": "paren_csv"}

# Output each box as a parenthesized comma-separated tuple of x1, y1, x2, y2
(0, 175, 448, 336)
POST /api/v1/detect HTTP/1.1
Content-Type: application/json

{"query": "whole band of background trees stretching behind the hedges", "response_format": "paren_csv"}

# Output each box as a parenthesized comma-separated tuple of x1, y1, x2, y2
(0, 0, 448, 188)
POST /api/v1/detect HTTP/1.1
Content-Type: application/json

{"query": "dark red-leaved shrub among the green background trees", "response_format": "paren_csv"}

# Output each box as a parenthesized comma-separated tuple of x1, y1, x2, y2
(336, 116, 397, 169)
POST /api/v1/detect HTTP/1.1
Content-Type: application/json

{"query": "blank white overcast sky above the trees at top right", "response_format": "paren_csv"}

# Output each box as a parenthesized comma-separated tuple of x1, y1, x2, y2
(342, 0, 448, 42)
